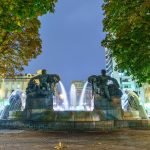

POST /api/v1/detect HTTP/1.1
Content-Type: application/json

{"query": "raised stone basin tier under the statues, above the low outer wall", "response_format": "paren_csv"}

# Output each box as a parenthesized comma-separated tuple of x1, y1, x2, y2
(9, 109, 122, 122)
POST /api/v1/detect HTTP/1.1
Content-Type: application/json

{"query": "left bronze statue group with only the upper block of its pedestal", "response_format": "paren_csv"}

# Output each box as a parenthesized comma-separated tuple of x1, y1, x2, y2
(26, 70, 60, 109)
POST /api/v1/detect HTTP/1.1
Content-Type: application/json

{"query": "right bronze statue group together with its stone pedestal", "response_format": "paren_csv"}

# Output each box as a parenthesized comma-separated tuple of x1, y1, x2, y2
(88, 70, 122, 119)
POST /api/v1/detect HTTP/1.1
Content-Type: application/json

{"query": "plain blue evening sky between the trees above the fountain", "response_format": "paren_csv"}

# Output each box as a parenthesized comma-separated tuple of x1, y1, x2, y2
(25, 0, 105, 89)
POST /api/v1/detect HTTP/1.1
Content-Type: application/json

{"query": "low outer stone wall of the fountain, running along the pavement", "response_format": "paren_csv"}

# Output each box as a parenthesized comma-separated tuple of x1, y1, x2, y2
(0, 120, 150, 131)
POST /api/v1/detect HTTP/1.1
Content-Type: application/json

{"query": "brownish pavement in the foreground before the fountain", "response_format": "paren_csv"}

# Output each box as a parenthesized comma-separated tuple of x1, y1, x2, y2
(0, 129, 150, 150)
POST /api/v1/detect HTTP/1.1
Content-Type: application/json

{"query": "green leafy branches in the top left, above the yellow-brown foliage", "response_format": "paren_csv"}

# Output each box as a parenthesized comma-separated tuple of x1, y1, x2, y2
(0, 0, 57, 31)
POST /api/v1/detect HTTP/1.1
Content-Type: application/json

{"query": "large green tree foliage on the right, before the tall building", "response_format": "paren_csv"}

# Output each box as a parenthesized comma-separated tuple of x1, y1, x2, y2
(102, 0, 150, 83)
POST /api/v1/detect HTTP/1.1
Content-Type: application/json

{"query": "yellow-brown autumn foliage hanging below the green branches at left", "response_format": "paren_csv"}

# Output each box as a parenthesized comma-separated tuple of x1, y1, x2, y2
(0, 19, 41, 76)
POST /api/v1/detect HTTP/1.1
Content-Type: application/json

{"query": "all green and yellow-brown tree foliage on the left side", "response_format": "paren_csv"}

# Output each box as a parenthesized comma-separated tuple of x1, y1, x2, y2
(0, 0, 57, 76)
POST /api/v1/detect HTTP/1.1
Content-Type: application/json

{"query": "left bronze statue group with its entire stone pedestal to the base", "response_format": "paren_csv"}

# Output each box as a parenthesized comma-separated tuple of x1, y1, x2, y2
(24, 70, 60, 120)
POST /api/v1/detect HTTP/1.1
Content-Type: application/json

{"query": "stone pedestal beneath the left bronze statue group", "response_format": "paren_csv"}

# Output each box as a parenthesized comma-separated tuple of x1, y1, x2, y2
(24, 90, 53, 120)
